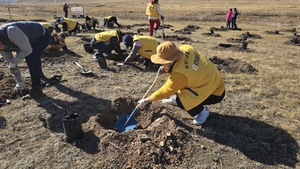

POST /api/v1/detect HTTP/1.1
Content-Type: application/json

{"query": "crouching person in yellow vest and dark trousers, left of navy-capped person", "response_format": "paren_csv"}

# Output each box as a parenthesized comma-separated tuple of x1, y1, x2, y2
(90, 30, 126, 69)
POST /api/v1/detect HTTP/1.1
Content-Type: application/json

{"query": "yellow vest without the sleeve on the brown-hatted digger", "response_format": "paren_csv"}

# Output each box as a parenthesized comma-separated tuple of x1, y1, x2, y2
(171, 45, 225, 111)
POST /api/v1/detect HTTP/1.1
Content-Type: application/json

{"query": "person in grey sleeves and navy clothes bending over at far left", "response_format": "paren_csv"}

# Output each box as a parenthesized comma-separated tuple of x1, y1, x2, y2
(0, 21, 51, 99)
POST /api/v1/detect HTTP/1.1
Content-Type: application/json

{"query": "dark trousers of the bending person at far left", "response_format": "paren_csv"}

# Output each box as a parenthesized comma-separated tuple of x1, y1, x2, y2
(25, 29, 51, 89)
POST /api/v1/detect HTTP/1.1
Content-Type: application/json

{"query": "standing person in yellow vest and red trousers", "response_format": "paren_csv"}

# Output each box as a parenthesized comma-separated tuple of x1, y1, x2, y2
(146, 0, 164, 36)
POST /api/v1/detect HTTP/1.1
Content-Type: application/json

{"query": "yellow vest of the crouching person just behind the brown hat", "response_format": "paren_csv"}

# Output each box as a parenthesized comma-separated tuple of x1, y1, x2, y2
(133, 35, 158, 59)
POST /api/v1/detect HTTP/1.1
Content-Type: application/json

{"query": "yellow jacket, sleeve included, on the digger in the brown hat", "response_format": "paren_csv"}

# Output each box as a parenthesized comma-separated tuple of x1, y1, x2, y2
(151, 45, 225, 111)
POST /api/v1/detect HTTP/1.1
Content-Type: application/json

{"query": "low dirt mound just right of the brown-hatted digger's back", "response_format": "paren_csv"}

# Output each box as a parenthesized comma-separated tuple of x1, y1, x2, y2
(209, 56, 258, 74)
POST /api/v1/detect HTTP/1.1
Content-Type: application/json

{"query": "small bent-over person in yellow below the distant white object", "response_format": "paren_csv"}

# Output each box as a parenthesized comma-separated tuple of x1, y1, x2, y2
(56, 17, 80, 35)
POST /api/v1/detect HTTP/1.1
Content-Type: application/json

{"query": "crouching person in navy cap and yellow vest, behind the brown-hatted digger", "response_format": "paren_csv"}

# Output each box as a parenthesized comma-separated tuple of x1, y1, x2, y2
(118, 35, 159, 69)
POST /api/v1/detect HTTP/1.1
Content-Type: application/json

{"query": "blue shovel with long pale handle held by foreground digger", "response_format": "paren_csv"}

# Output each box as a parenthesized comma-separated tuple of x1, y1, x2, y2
(114, 68, 167, 132)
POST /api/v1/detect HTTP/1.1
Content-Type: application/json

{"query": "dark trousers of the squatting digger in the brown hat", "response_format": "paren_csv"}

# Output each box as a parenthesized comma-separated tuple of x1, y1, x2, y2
(176, 91, 225, 117)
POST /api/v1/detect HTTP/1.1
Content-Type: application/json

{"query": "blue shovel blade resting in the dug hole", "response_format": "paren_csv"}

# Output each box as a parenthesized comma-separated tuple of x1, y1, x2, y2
(114, 113, 138, 132)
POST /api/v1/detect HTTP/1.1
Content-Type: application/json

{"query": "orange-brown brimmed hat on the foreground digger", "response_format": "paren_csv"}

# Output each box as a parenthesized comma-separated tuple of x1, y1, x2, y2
(151, 41, 184, 64)
